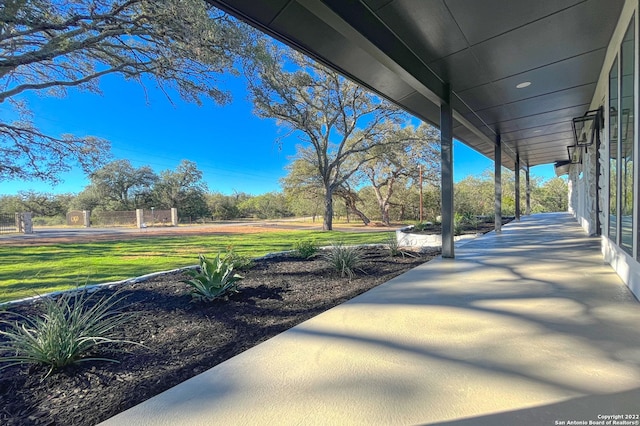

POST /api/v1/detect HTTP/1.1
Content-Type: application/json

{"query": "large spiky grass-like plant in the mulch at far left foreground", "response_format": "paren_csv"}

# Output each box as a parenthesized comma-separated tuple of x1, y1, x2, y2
(0, 291, 142, 377)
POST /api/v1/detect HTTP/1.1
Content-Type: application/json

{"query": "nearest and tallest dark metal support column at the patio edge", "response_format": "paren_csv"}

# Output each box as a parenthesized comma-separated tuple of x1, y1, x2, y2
(440, 86, 455, 258)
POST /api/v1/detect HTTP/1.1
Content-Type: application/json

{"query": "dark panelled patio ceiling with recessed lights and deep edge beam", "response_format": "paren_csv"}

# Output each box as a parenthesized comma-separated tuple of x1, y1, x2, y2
(208, 0, 624, 169)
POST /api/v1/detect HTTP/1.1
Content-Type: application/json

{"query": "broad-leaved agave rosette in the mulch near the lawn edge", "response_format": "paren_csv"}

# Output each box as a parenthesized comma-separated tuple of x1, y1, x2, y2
(183, 253, 244, 301)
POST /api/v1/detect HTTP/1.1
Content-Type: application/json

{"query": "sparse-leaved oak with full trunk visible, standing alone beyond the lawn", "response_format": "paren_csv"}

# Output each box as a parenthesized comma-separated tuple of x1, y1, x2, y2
(245, 46, 406, 230)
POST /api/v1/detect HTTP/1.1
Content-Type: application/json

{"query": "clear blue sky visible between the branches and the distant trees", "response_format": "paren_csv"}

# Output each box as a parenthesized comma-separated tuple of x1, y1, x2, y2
(0, 71, 554, 195)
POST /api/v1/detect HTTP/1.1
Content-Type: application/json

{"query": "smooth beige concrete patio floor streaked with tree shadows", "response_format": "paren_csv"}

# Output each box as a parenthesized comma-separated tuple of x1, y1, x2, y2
(103, 213, 640, 425)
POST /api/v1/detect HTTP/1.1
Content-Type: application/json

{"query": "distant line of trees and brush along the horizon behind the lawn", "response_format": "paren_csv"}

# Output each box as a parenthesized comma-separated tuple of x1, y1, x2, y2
(0, 160, 568, 225)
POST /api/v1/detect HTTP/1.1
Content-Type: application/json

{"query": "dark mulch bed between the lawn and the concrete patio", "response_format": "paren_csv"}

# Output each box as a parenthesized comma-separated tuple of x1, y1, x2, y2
(0, 248, 439, 425)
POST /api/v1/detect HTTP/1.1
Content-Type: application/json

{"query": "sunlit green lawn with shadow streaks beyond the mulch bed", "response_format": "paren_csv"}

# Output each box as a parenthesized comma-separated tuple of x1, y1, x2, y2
(0, 231, 388, 302)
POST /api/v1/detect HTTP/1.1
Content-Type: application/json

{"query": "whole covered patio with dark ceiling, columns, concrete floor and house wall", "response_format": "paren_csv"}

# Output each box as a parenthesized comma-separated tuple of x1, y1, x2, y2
(104, 0, 640, 426)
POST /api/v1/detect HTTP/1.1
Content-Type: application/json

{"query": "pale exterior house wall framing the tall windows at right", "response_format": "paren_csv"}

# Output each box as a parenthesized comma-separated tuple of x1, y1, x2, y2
(569, 0, 640, 299)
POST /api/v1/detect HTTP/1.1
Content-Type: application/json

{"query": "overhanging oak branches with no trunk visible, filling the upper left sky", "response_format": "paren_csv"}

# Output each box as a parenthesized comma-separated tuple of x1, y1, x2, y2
(0, 0, 243, 182)
